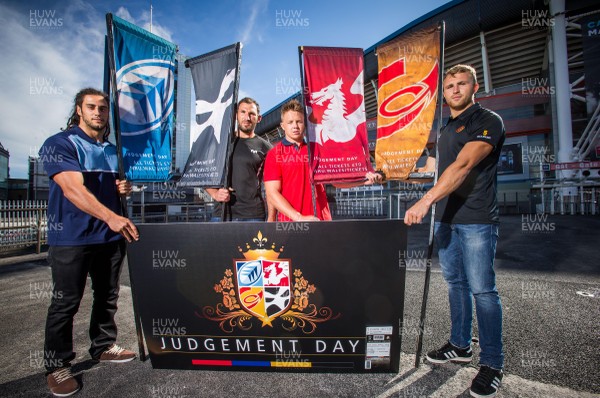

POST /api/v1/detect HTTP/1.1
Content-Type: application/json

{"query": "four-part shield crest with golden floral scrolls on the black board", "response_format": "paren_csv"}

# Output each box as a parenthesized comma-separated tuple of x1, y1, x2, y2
(199, 231, 339, 334)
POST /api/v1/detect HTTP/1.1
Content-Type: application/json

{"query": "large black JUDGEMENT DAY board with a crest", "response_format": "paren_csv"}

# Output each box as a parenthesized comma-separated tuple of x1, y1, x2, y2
(128, 220, 407, 373)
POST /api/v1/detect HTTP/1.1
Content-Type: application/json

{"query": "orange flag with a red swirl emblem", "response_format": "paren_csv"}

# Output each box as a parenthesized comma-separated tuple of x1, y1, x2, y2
(375, 27, 440, 180)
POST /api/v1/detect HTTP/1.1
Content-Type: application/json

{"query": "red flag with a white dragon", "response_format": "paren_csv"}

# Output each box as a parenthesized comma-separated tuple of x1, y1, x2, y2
(303, 47, 373, 183)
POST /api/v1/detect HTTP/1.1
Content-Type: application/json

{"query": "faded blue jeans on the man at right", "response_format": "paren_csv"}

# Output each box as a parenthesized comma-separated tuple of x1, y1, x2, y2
(435, 222, 504, 369)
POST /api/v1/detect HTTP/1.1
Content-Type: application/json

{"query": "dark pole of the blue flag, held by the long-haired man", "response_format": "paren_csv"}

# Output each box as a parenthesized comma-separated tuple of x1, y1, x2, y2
(106, 13, 146, 361)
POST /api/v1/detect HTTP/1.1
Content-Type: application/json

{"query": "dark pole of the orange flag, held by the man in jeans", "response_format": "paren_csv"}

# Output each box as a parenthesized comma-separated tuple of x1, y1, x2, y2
(415, 21, 446, 368)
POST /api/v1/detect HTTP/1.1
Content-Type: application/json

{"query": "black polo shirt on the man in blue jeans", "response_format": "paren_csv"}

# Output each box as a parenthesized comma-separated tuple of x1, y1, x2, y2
(435, 104, 506, 224)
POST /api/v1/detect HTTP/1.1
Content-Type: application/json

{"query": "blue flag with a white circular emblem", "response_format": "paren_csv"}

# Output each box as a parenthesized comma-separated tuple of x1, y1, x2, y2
(108, 16, 177, 181)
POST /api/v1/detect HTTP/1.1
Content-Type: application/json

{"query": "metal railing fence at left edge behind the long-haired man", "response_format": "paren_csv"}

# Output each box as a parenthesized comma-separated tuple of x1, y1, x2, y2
(0, 200, 48, 253)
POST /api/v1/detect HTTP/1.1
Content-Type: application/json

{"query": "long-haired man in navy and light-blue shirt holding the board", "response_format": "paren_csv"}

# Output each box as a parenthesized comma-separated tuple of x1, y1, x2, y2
(39, 88, 139, 397)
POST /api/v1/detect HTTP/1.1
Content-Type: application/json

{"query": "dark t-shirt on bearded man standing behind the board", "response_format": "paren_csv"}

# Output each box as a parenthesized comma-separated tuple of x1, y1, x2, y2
(215, 135, 272, 219)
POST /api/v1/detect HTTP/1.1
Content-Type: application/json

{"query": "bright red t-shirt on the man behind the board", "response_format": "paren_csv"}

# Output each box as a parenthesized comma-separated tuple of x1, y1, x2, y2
(263, 138, 331, 221)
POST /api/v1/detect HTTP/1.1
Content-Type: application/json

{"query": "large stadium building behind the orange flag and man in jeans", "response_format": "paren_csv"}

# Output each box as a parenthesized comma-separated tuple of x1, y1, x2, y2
(257, 0, 600, 218)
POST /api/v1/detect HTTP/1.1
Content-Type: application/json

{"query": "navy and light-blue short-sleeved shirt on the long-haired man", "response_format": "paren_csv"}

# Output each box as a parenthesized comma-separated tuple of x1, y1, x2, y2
(39, 127, 122, 246)
